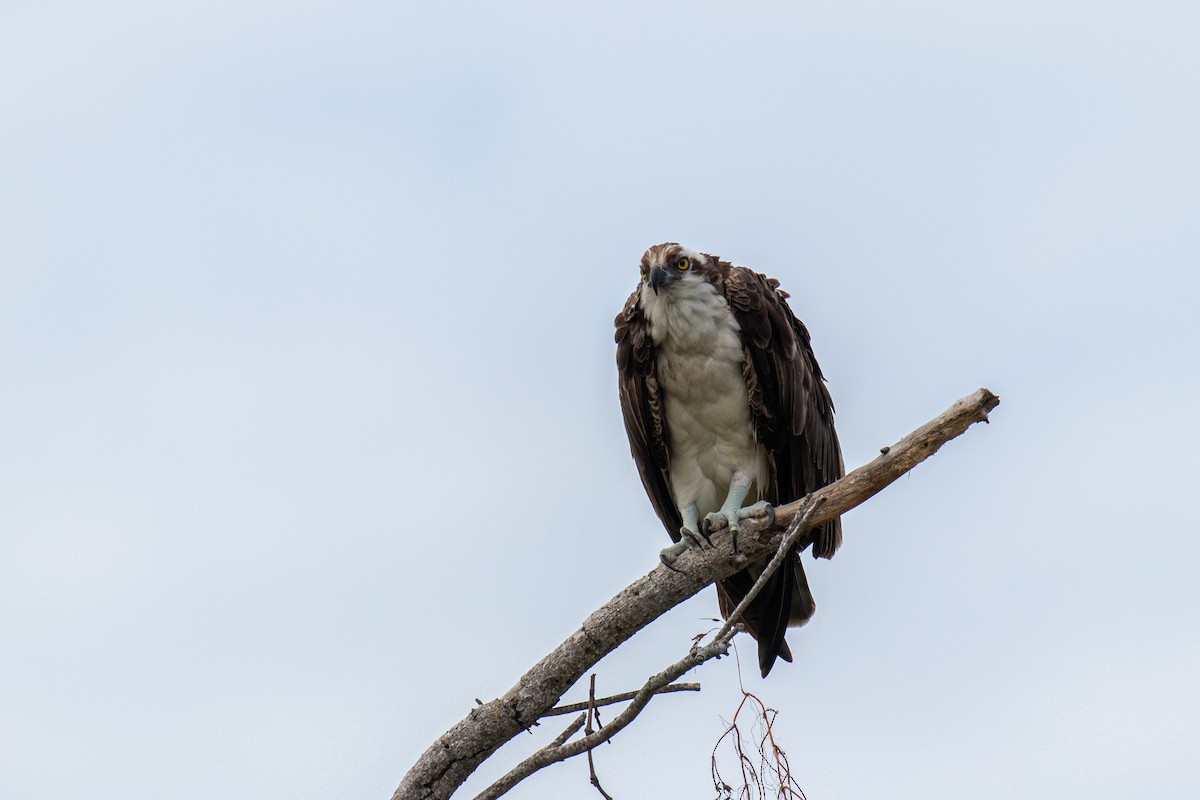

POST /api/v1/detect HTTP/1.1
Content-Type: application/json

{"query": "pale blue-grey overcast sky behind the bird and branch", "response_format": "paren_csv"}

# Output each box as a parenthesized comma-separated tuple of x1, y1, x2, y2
(0, 0, 1200, 800)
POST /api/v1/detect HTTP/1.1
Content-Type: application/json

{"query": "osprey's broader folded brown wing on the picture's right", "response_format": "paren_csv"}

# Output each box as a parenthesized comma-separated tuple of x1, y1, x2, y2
(724, 266, 845, 558)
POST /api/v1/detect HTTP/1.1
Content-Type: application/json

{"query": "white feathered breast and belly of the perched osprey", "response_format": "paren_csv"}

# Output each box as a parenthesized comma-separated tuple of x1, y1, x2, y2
(641, 275, 767, 518)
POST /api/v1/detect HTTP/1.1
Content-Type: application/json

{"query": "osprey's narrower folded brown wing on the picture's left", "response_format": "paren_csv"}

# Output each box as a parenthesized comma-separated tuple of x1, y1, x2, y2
(614, 291, 683, 541)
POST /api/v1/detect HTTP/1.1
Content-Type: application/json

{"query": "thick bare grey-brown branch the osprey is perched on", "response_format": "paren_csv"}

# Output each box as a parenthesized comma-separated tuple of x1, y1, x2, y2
(392, 389, 1000, 800)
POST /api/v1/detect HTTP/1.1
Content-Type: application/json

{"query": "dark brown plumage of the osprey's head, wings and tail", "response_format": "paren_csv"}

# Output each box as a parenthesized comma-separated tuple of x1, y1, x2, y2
(616, 242, 844, 675)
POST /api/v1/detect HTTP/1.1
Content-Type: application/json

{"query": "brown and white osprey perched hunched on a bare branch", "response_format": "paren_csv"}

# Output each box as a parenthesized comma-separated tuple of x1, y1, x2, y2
(616, 242, 844, 678)
